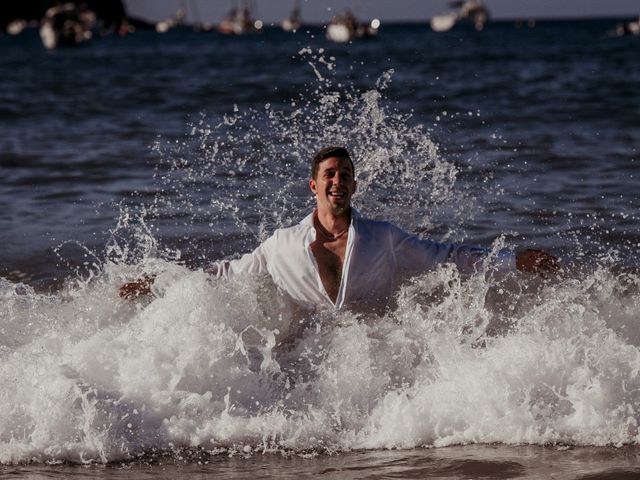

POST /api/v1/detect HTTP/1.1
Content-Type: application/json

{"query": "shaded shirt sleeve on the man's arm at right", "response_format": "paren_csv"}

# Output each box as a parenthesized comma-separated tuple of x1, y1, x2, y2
(391, 227, 516, 273)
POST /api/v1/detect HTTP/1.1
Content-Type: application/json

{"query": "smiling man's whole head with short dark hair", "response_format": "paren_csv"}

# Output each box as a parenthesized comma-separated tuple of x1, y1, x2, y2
(309, 147, 356, 215)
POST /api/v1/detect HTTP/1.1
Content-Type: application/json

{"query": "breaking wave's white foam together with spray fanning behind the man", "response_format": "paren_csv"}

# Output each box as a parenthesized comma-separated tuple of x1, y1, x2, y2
(0, 50, 640, 463)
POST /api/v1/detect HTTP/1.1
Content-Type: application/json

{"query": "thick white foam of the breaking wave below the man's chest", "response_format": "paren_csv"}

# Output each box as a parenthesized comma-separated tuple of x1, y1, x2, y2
(0, 258, 640, 462)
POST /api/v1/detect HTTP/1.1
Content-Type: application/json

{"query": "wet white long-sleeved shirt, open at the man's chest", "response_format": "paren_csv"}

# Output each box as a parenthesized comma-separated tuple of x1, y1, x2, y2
(205, 208, 515, 310)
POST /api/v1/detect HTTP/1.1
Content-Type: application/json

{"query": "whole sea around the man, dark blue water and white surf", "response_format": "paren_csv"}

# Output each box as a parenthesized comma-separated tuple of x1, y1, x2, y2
(0, 19, 640, 479)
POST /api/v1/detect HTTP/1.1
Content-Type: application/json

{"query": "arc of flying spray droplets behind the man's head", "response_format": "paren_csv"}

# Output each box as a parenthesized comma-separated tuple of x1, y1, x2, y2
(140, 49, 473, 268)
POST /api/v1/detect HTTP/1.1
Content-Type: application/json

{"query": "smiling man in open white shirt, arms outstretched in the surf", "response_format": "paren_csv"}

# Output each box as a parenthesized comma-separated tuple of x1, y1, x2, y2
(120, 147, 558, 310)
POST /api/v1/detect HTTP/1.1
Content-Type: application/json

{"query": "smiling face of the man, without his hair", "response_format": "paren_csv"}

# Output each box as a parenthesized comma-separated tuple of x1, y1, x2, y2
(309, 157, 356, 215)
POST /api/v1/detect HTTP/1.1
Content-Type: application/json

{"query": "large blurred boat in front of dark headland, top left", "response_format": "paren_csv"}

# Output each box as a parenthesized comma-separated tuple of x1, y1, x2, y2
(40, 2, 96, 49)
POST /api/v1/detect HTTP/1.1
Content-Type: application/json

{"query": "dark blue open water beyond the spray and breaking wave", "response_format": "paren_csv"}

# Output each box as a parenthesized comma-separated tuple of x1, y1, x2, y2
(0, 20, 640, 285)
